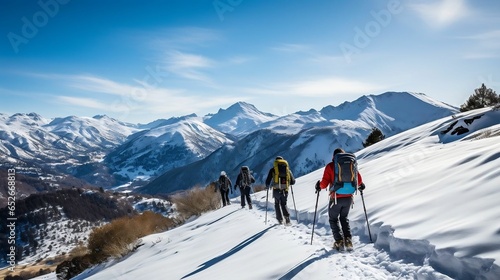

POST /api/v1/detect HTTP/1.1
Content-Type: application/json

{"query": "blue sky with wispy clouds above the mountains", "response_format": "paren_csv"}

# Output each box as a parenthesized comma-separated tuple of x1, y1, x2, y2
(0, 0, 500, 123)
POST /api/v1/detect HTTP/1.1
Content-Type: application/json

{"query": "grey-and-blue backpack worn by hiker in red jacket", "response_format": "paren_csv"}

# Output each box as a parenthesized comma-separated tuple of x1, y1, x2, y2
(330, 153, 358, 194)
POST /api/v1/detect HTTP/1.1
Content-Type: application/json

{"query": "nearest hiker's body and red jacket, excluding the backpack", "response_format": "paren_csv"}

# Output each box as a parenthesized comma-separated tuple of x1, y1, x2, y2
(316, 148, 365, 251)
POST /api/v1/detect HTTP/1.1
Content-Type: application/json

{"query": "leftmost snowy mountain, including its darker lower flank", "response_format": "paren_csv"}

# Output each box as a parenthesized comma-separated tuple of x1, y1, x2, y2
(0, 113, 141, 191)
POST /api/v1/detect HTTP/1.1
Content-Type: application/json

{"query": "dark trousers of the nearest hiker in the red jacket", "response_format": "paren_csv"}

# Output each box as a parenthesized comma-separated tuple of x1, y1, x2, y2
(328, 197, 352, 241)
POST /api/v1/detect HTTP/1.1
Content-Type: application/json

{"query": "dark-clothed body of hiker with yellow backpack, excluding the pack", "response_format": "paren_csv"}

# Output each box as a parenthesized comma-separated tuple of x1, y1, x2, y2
(266, 156, 295, 224)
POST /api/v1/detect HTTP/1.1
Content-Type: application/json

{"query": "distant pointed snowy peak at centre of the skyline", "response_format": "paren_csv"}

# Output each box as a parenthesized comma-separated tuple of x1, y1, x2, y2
(204, 102, 278, 136)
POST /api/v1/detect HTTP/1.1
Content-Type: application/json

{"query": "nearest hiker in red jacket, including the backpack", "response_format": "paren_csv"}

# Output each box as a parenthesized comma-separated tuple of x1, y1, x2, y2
(315, 148, 365, 251)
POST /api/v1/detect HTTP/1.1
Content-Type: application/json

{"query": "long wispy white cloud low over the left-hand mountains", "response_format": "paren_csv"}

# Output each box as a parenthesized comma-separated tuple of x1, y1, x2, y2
(55, 75, 241, 121)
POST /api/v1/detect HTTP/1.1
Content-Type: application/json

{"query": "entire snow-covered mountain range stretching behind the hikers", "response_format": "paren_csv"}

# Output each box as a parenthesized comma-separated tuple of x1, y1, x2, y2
(0, 92, 458, 197)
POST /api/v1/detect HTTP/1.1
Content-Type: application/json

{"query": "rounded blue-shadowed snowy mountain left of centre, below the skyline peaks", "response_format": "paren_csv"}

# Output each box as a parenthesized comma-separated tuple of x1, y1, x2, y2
(105, 115, 232, 184)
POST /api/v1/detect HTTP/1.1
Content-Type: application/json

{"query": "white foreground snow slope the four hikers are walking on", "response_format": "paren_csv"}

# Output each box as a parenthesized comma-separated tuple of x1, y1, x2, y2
(40, 106, 500, 280)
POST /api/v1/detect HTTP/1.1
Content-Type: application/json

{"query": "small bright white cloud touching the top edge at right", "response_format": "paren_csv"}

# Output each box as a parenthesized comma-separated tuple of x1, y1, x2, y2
(409, 0, 470, 28)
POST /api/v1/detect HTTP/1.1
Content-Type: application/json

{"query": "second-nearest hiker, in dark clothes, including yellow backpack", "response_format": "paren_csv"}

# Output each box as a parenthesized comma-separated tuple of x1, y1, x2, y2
(266, 156, 295, 224)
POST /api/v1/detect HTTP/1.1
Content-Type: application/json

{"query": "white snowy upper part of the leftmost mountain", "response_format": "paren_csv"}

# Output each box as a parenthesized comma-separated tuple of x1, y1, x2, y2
(0, 113, 139, 165)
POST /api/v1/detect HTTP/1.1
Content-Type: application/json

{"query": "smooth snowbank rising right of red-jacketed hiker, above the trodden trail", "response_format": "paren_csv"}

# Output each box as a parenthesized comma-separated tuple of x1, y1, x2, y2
(358, 106, 500, 264)
